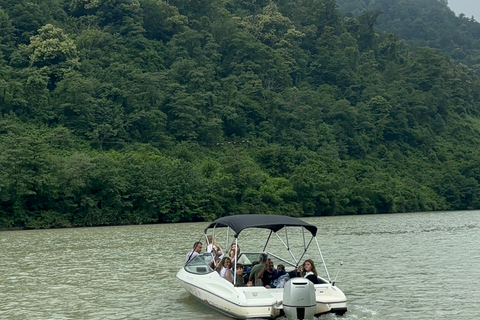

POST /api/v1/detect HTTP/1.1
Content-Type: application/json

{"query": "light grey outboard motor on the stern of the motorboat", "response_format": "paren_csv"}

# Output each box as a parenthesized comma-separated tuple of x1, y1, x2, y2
(283, 278, 317, 320)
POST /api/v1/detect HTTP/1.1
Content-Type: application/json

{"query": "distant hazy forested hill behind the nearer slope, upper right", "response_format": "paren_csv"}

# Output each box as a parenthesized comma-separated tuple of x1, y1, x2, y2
(337, 0, 480, 74)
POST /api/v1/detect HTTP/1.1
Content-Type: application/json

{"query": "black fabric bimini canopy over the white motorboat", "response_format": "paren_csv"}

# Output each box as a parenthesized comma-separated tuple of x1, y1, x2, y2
(205, 214, 317, 237)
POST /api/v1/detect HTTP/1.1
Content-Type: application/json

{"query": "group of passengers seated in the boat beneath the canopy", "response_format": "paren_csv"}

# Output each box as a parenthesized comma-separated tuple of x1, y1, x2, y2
(185, 236, 319, 288)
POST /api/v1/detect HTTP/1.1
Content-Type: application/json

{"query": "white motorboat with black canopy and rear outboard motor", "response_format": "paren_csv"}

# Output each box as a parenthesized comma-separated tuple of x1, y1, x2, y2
(177, 214, 347, 319)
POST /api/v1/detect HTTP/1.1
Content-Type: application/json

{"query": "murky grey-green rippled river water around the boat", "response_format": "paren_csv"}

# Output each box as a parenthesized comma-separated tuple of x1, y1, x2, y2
(0, 211, 480, 320)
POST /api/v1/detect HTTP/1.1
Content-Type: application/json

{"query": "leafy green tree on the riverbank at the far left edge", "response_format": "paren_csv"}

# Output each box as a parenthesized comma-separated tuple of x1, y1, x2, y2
(0, 117, 55, 227)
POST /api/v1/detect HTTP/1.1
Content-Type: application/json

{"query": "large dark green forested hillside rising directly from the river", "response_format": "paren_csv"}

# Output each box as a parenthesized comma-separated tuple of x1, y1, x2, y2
(0, 0, 480, 228)
